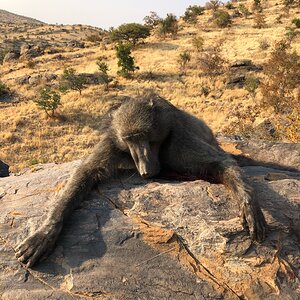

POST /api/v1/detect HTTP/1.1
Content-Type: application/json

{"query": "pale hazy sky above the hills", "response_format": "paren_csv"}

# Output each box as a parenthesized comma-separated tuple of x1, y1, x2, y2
(0, 0, 208, 29)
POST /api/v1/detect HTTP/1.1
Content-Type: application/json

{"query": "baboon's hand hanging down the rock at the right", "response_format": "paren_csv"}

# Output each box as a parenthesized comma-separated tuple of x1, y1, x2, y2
(242, 203, 267, 242)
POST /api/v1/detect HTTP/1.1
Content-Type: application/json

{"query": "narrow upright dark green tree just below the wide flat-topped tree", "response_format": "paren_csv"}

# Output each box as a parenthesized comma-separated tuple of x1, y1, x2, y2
(116, 43, 138, 78)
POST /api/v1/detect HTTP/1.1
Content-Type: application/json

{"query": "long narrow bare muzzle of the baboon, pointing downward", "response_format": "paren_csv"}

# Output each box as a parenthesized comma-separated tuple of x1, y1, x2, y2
(128, 141, 160, 178)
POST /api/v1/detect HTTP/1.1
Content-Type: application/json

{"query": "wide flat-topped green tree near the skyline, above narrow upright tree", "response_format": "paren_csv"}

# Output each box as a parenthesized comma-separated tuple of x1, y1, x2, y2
(110, 23, 150, 45)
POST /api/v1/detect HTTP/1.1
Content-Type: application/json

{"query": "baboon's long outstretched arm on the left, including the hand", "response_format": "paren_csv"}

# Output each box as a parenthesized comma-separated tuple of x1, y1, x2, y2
(16, 136, 122, 267)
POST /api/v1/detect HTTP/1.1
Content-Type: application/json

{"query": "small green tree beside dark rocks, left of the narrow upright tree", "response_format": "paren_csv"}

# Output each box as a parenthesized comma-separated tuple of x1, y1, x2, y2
(60, 68, 86, 95)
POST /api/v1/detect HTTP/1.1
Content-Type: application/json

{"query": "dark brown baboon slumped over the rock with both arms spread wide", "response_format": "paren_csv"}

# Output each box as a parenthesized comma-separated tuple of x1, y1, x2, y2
(16, 93, 266, 267)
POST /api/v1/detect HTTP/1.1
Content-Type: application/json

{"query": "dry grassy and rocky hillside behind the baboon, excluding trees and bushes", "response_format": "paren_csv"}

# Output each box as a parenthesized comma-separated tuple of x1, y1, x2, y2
(0, 0, 300, 171)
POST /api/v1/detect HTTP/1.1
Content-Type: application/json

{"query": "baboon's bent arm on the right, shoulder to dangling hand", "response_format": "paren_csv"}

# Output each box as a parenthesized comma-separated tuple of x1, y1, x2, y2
(168, 139, 266, 241)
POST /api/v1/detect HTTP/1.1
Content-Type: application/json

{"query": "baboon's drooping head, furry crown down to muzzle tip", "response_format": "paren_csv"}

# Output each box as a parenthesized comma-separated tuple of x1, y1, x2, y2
(112, 99, 164, 178)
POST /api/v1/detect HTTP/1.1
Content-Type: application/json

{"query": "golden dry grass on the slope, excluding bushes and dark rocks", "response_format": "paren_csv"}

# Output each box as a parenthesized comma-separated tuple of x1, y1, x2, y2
(0, 1, 300, 172)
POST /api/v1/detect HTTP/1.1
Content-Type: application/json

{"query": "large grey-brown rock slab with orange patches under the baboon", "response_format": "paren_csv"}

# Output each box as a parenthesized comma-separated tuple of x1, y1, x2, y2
(0, 161, 300, 299)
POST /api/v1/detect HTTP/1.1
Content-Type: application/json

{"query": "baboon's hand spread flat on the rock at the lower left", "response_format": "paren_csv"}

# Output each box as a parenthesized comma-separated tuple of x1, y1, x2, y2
(15, 224, 61, 268)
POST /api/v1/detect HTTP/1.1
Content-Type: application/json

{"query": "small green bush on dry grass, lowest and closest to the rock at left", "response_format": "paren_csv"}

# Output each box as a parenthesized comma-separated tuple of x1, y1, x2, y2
(33, 87, 61, 118)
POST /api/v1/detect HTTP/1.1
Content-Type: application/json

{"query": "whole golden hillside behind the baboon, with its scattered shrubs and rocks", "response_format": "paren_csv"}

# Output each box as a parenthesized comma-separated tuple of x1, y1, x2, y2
(0, 0, 300, 171)
